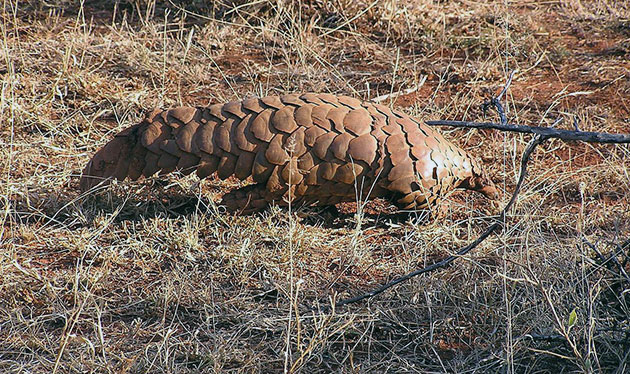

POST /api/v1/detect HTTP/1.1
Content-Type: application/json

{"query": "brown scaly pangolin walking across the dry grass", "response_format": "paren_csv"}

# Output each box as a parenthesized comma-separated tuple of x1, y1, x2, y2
(80, 93, 497, 212)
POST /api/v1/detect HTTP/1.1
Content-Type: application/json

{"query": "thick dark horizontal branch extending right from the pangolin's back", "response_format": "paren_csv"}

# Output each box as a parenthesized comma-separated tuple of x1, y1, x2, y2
(425, 121, 630, 144)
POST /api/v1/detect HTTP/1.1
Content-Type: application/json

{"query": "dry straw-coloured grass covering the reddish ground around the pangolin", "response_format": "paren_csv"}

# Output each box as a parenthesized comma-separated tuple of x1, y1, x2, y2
(0, 0, 630, 373)
